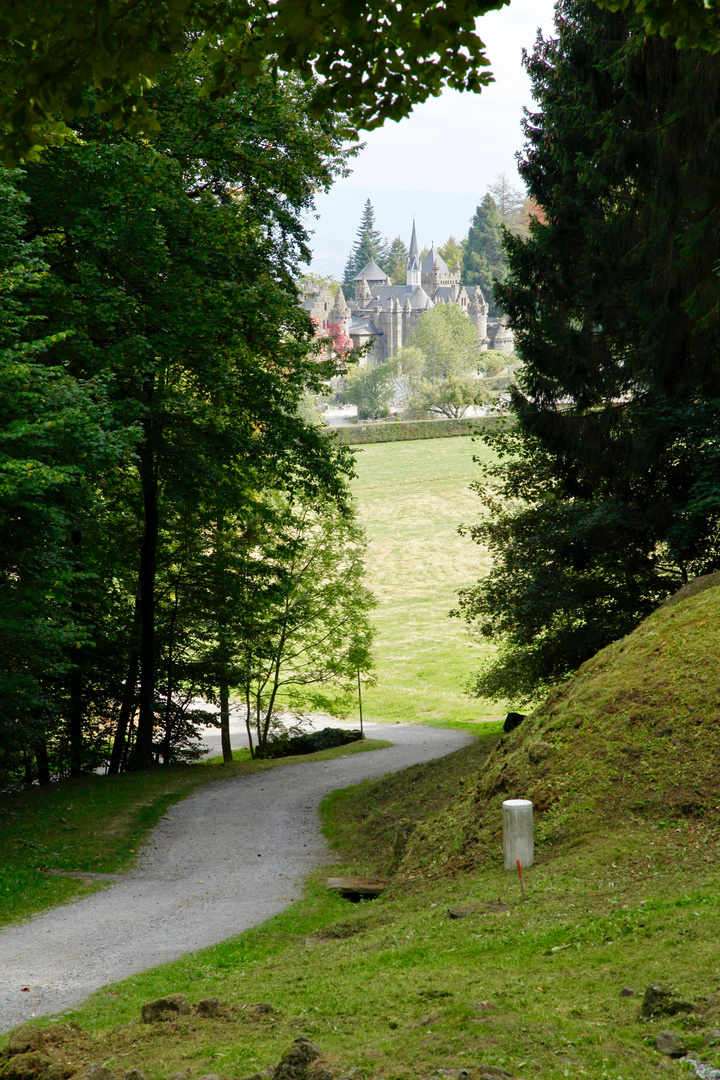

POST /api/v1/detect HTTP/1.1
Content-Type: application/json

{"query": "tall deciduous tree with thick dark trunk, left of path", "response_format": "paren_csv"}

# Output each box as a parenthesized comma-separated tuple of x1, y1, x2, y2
(8, 60, 354, 766)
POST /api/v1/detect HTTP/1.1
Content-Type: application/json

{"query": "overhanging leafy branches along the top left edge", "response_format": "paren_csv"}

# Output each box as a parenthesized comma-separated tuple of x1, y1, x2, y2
(0, 0, 506, 161)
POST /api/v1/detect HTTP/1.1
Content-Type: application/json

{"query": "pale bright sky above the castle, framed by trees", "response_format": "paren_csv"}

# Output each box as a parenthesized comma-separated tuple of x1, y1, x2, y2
(304, 0, 553, 276)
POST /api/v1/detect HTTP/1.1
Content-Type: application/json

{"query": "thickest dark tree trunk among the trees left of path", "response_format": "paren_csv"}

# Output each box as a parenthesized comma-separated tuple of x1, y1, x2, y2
(132, 437, 160, 769)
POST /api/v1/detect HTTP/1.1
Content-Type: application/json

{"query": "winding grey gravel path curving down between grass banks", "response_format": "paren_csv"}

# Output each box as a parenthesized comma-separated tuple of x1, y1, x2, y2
(0, 724, 470, 1031)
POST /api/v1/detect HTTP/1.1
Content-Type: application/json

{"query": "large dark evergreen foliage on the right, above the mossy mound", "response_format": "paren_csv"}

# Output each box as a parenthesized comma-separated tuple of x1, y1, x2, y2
(461, 0, 720, 697)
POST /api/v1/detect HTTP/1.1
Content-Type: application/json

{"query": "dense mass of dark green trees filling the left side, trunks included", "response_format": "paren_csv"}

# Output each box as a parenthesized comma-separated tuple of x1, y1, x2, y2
(0, 58, 367, 779)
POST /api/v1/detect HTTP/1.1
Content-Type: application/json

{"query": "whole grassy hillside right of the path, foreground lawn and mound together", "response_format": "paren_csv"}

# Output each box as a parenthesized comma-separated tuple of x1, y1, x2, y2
(9, 590, 720, 1080)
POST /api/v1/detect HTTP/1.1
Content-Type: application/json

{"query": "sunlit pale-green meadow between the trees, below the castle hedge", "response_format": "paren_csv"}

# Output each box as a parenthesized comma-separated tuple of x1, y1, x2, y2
(345, 437, 505, 726)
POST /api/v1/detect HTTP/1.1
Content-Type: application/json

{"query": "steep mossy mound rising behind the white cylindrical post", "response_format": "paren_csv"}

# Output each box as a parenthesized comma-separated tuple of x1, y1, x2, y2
(390, 589, 720, 876)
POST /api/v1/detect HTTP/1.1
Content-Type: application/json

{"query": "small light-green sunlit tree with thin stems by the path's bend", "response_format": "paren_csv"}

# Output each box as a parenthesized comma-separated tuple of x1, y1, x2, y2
(208, 491, 372, 757)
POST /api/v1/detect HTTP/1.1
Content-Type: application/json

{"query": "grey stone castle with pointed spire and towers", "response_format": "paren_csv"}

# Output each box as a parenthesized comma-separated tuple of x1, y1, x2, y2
(302, 221, 514, 364)
